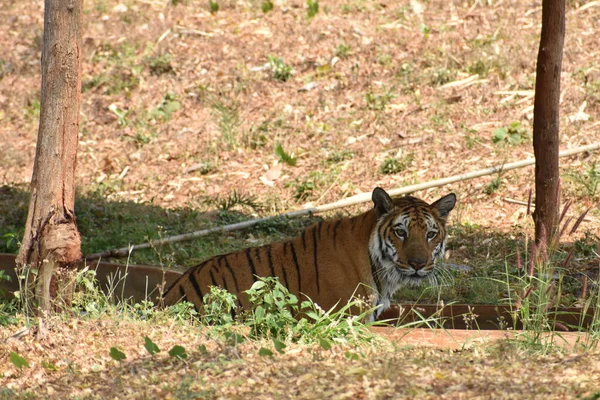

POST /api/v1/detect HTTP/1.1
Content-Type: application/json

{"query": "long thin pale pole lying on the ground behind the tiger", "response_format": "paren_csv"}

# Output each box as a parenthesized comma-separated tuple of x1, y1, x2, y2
(85, 142, 600, 260)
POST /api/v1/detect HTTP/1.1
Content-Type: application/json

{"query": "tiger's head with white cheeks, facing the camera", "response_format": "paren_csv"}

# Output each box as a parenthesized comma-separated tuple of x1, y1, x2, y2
(369, 188, 456, 298)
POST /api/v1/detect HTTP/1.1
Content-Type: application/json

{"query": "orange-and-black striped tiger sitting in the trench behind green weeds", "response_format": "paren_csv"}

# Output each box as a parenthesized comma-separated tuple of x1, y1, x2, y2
(163, 187, 456, 320)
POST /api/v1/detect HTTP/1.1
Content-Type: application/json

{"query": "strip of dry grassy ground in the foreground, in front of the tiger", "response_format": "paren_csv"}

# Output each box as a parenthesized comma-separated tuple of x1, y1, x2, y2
(0, 319, 600, 399)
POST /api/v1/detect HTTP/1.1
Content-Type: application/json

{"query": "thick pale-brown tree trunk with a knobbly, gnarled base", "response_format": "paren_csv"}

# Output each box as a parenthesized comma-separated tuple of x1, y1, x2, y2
(17, 0, 82, 311)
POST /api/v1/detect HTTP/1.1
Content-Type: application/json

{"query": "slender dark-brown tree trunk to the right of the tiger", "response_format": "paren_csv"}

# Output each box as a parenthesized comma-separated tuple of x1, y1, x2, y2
(533, 0, 565, 244)
